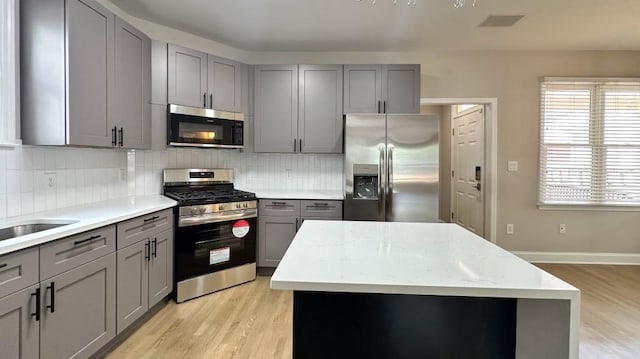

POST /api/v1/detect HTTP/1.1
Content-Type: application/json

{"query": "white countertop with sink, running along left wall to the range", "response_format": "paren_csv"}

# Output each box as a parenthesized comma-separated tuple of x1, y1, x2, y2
(0, 195, 177, 255)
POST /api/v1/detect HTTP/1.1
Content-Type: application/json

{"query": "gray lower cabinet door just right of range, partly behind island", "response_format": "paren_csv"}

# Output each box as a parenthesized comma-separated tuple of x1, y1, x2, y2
(258, 216, 298, 267)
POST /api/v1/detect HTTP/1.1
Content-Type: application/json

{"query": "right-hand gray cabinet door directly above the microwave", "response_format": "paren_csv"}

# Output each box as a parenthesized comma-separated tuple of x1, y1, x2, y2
(207, 55, 242, 112)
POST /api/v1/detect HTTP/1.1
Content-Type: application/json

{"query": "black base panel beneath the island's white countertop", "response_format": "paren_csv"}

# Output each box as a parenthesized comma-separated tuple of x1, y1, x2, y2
(293, 291, 517, 359)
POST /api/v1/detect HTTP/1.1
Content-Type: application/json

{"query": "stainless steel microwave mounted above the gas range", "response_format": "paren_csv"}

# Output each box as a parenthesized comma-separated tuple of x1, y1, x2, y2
(167, 105, 244, 148)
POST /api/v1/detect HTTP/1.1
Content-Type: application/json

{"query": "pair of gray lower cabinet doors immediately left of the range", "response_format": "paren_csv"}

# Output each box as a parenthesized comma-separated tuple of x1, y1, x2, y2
(116, 230, 173, 334)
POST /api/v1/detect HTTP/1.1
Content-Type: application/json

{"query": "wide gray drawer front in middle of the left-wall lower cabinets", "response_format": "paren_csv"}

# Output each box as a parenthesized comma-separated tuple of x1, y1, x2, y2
(40, 225, 116, 281)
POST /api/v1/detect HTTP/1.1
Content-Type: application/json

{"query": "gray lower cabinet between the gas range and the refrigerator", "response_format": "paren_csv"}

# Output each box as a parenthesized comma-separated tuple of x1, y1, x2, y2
(258, 199, 342, 267)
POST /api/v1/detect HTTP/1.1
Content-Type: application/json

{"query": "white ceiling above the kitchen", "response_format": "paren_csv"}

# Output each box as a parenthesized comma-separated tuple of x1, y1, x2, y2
(111, 0, 640, 51)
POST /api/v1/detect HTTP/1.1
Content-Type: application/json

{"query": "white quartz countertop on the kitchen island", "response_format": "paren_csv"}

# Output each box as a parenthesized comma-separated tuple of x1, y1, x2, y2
(271, 220, 580, 300)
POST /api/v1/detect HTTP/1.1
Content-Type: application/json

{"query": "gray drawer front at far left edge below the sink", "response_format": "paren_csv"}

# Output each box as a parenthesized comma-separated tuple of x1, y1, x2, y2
(0, 247, 38, 298)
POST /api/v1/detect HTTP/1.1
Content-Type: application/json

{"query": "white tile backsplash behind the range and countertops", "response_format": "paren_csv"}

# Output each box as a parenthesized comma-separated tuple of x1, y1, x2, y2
(0, 146, 343, 219)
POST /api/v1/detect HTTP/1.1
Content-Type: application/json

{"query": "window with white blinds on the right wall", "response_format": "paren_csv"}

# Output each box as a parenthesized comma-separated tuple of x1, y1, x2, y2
(538, 78, 640, 206)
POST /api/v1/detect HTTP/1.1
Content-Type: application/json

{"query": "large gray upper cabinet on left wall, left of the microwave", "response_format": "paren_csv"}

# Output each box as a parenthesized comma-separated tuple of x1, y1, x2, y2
(20, 0, 151, 148)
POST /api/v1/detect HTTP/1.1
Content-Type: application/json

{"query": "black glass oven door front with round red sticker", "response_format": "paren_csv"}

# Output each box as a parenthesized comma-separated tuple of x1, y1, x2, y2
(175, 218, 257, 281)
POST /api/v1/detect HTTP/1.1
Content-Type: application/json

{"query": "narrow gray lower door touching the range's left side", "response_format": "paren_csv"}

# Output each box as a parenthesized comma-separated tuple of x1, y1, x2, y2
(149, 230, 173, 308)
